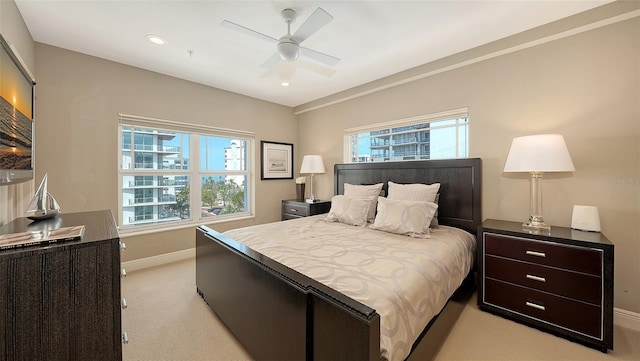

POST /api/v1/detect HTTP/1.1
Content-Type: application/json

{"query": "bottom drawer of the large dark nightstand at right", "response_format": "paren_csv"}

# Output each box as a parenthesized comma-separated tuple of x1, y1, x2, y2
(484, 278, 602, 340)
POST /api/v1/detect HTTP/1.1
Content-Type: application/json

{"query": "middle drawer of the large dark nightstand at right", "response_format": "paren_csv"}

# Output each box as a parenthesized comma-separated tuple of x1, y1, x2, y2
(484, 255, 602, 306)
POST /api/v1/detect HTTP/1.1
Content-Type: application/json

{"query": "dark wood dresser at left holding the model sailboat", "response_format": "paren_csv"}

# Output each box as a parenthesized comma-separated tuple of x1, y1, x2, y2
(0, 211, 122, 361)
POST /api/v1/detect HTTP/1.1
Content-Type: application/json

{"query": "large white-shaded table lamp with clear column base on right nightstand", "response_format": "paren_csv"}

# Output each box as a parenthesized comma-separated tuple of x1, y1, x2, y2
(504, 134, 576, 230)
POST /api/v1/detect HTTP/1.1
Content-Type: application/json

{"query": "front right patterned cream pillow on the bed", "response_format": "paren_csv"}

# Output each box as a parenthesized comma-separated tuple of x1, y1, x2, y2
(369, 197, 438, 238)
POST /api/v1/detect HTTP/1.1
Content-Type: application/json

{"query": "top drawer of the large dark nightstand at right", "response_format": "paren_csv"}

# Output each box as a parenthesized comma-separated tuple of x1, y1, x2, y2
(484, 233, 602, 276)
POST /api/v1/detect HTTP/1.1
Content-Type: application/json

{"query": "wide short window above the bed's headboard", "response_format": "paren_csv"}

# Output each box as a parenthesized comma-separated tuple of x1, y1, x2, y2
(344, 108, 469, 163)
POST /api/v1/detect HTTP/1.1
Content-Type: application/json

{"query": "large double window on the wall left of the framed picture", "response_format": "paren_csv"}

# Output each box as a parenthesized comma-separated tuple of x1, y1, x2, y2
(118, 115, 254, 230)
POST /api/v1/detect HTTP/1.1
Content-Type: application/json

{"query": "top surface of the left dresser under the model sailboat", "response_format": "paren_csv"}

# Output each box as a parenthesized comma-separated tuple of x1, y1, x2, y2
(0, 210, 120, 253)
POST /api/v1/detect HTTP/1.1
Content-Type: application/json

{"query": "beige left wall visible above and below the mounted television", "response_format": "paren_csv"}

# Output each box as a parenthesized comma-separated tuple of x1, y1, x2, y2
(0, 0, 37, 225)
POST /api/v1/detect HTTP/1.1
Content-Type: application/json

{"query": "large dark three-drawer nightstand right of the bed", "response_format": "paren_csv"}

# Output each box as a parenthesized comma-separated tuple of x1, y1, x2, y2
(478, 219, 613, 352)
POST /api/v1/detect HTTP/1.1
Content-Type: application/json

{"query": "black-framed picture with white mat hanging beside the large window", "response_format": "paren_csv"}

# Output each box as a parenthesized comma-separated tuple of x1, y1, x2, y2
(260, 140, 293, 180)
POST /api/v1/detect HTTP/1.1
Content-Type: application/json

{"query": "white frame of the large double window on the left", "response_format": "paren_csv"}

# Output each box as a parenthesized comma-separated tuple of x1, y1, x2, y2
(116, 114, 255, 235)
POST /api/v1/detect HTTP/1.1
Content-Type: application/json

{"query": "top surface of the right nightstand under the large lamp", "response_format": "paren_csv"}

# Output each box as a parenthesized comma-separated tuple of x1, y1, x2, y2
(482, 219, 612, 245)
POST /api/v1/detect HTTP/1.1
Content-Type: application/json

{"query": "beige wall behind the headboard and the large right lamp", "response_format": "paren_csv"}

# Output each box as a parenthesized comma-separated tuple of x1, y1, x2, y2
(299, 13, 640, 312)
